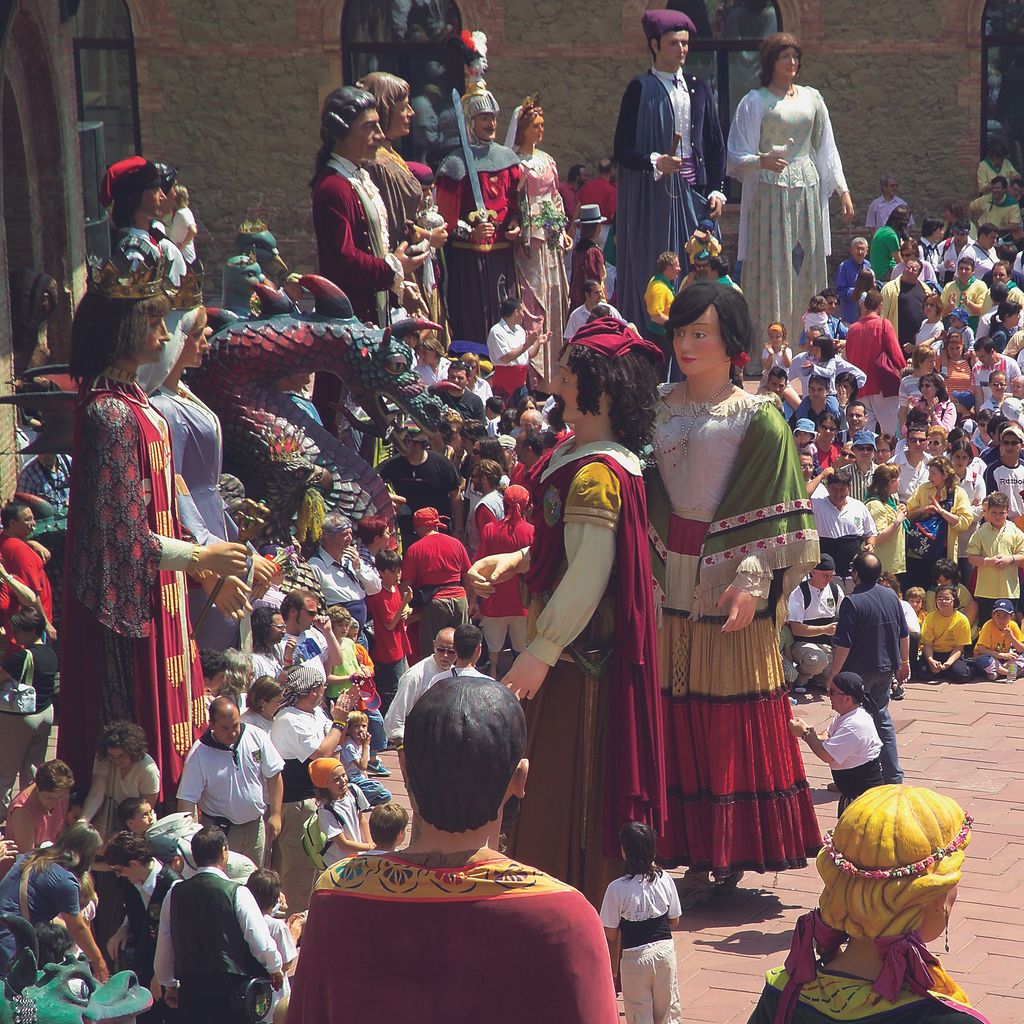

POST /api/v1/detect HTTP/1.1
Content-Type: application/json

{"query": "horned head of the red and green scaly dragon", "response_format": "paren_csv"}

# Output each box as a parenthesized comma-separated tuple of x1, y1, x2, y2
(301, 274, 444, 435)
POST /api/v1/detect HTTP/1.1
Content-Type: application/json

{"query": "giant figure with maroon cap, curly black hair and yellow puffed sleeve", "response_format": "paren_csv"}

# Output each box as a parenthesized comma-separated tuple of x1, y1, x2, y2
(469, 316, 665, 905)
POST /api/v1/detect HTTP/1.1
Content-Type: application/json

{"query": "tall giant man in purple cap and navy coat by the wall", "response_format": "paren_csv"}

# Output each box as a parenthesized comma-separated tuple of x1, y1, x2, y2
(614, 10, 725, 344)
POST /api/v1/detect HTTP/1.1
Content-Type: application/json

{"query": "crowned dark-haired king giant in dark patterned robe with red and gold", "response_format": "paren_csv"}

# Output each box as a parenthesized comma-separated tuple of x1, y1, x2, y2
(57, 234, 247, 794)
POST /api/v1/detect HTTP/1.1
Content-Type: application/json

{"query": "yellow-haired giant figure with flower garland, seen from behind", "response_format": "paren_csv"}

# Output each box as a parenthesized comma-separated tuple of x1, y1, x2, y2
(749, 785, 985, 1024)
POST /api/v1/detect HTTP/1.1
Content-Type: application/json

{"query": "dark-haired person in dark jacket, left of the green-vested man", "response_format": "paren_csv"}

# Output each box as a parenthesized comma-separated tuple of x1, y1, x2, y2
(103, 831, 181, 1024)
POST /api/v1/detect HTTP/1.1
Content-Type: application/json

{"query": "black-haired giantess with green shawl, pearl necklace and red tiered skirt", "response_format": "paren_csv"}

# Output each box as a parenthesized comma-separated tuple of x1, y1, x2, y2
(648, 284, 820, 905)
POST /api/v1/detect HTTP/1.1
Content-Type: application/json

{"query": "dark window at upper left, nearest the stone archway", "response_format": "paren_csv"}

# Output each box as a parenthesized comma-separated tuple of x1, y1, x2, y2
(75, 0, 142, 164)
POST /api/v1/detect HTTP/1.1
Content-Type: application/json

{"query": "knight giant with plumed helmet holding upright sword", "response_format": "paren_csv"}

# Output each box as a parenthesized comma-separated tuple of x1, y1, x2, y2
(436, 32, 521, 342)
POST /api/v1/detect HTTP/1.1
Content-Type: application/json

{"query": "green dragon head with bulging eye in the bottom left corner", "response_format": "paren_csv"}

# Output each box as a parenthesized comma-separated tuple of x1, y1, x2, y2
(0, 914, 153, 1024)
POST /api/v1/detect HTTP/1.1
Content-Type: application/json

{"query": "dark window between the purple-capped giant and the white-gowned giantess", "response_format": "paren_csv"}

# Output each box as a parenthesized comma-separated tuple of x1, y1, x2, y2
(666, 0, 782, 134)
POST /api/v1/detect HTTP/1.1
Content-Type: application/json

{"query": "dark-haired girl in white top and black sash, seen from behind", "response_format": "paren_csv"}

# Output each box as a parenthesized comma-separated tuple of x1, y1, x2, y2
(601, 821, 683, 1024)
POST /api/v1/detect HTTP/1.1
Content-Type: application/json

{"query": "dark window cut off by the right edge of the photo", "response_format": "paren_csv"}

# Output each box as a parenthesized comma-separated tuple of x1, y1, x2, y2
(981, 0, 1024, 170)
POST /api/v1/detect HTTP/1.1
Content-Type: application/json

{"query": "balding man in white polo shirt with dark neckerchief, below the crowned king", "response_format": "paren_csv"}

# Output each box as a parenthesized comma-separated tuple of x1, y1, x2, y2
(178, 697, 285, 864)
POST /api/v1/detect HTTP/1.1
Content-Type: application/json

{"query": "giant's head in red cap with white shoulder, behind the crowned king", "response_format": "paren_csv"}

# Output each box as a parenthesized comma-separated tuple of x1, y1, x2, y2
(99, 157, 186, 287)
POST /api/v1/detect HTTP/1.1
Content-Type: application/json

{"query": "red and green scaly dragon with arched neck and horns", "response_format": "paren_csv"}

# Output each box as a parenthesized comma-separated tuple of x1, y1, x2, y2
(189, 274, 444, 544)
